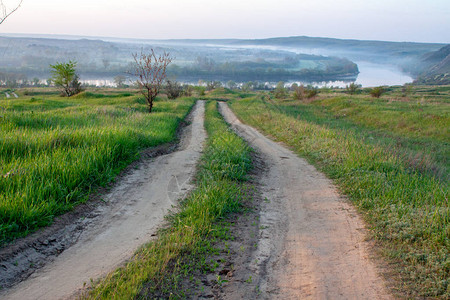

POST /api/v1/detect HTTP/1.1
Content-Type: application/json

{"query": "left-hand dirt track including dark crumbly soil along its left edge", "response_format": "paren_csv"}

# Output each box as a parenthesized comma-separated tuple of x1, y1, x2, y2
(0, 101, 206, 299)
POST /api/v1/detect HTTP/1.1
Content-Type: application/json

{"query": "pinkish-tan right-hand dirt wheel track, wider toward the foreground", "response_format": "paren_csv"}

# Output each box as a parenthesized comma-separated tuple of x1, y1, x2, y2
(220, 103, 391, 299)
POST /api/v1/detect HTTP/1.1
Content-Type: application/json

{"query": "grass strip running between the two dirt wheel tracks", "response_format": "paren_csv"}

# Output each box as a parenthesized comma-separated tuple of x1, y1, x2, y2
(85, 102, 251, 299)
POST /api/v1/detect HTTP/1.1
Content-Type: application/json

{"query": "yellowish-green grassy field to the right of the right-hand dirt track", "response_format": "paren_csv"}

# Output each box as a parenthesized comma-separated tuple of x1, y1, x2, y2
(232, 88, 450, 297)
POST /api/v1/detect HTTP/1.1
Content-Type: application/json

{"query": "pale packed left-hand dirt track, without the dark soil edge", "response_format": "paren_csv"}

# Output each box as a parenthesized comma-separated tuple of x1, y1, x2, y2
(0, 101, 206, 300)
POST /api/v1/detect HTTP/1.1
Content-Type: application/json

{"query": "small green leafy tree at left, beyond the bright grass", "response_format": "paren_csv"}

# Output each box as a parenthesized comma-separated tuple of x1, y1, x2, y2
(50, 61, 83, 97)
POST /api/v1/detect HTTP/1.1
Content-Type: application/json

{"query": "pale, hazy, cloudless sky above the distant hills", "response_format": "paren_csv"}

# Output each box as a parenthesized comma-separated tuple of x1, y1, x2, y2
(0, 0, 450, 43)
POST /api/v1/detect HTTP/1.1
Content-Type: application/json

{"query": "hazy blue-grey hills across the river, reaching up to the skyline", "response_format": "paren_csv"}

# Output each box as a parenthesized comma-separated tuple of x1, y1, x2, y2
(0, 35, 446, 84)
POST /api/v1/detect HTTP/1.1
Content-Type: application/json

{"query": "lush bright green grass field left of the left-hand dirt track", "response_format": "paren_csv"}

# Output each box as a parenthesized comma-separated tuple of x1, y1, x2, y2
(0, 93, 194, 245)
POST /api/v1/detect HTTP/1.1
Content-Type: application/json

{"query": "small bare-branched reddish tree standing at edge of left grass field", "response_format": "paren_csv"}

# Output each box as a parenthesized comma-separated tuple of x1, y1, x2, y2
(129, 49, 172, 113)
